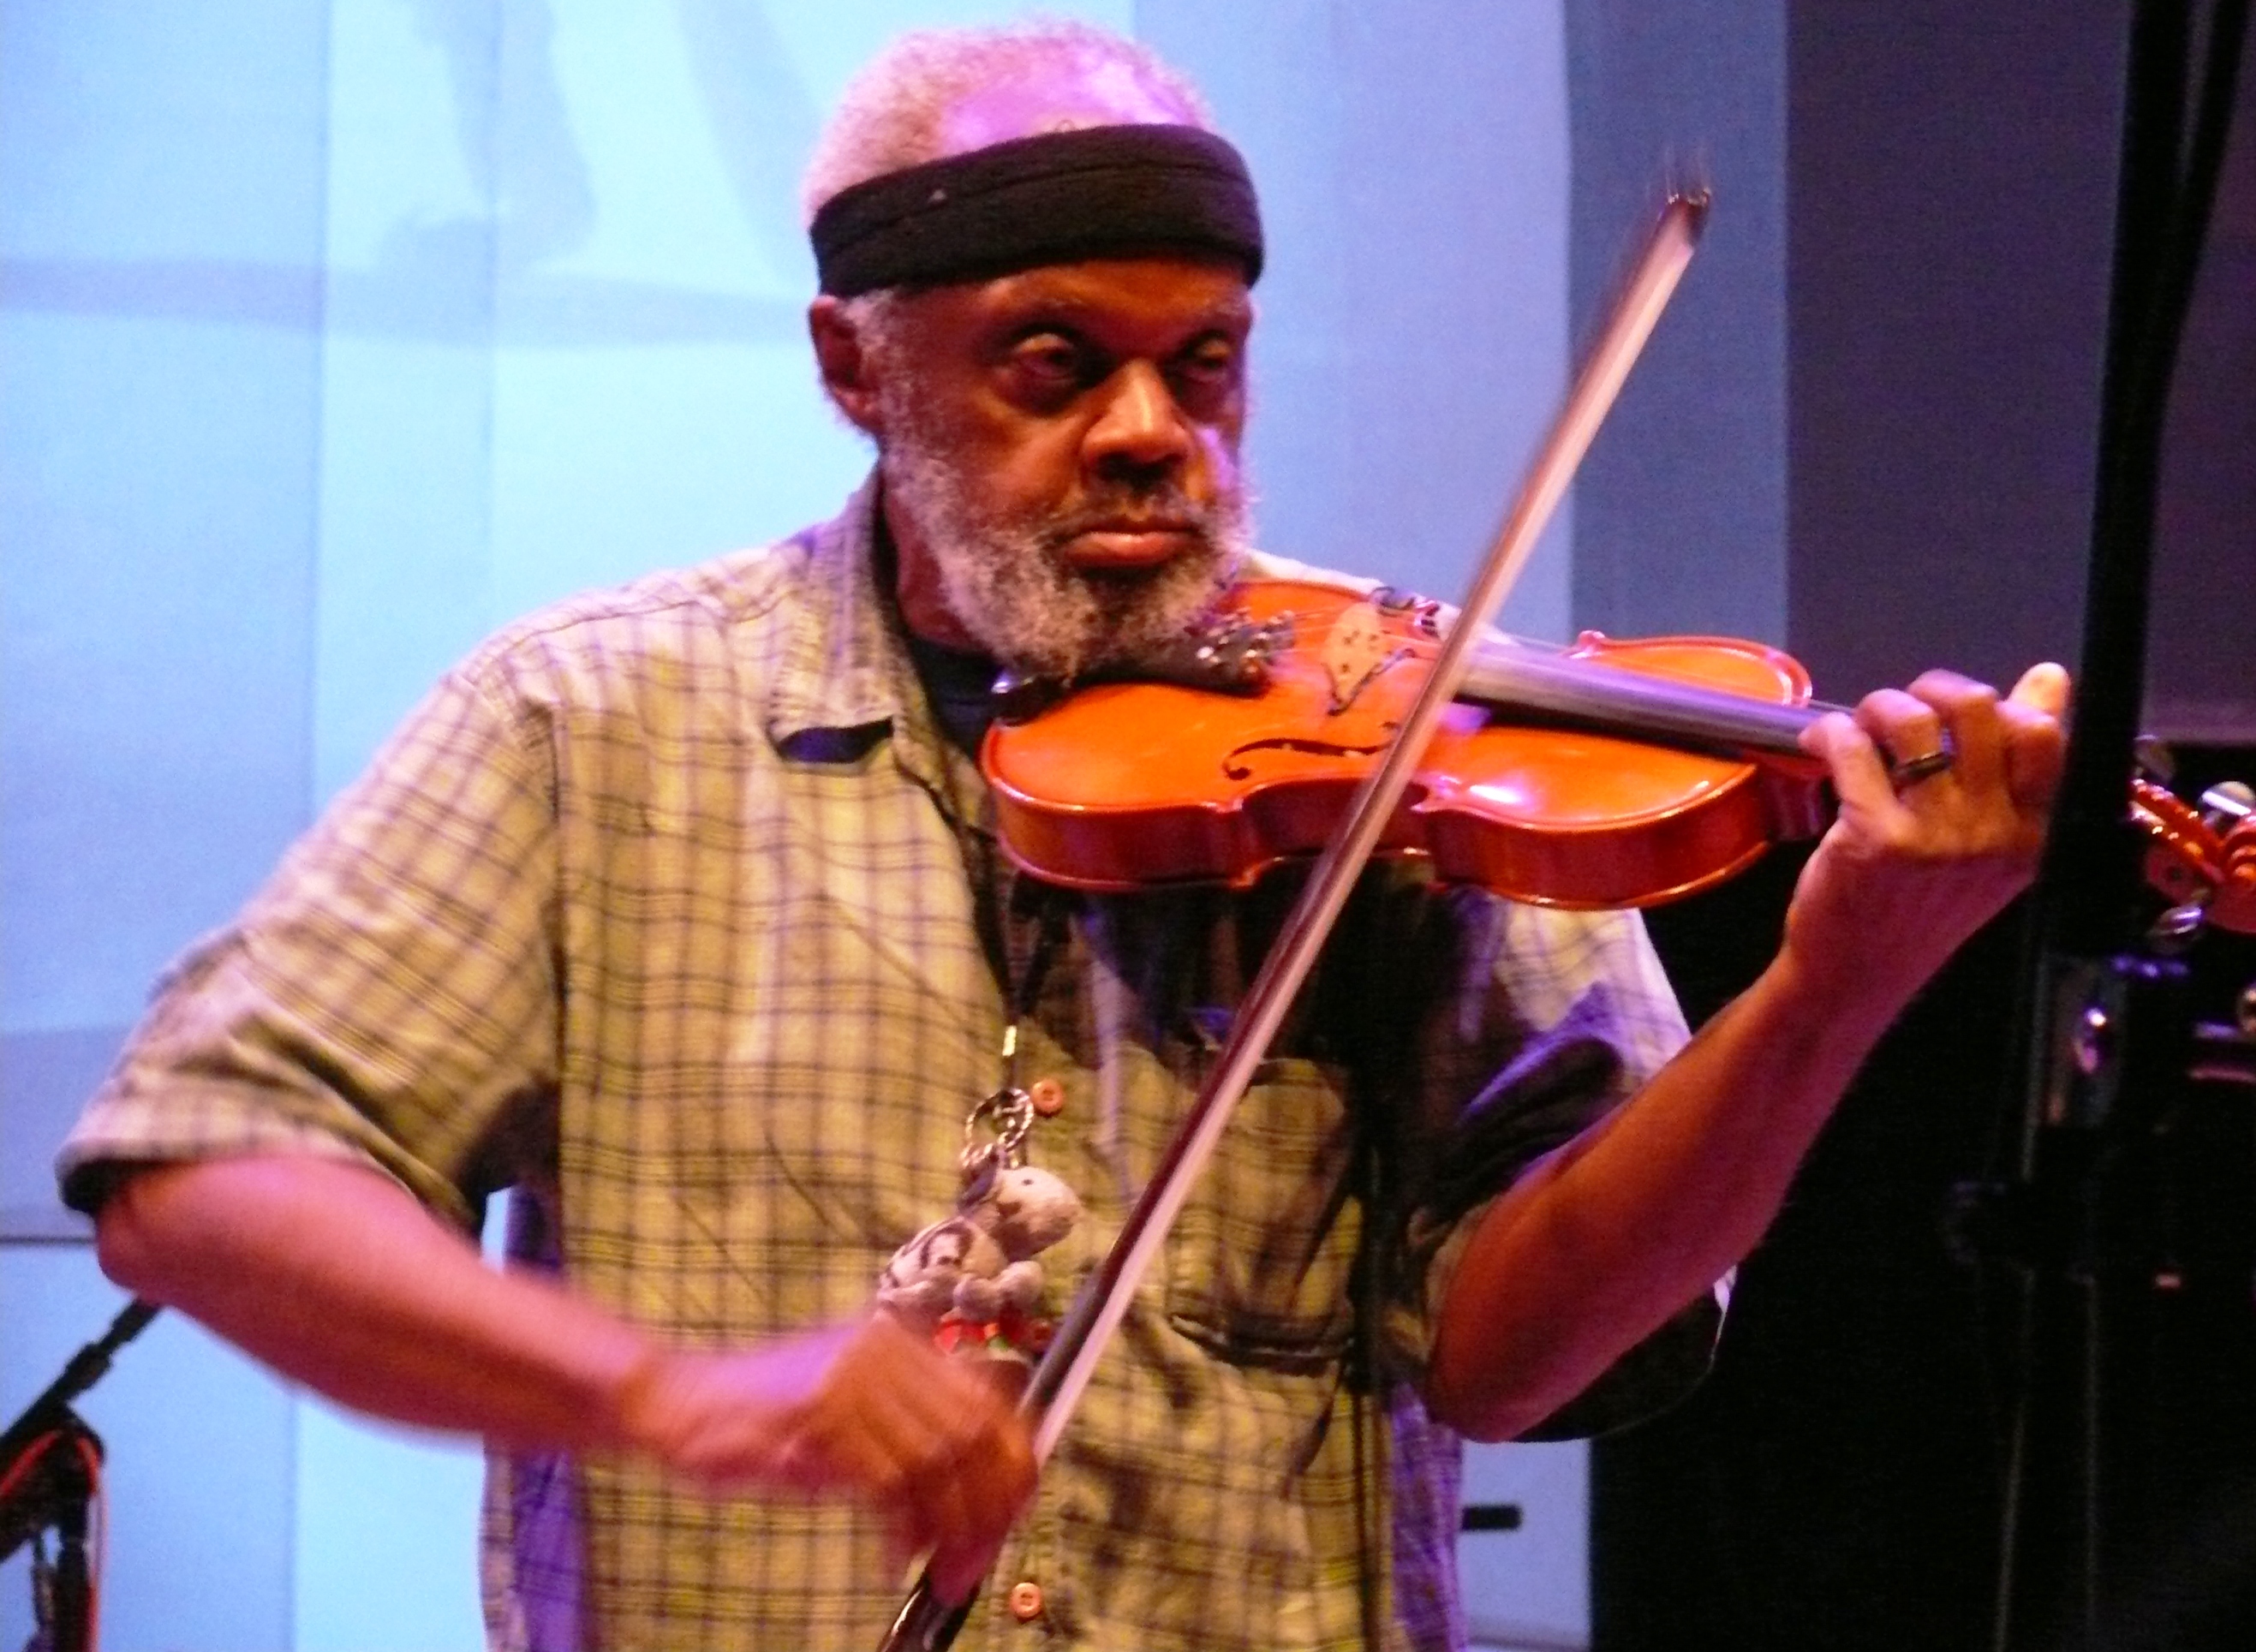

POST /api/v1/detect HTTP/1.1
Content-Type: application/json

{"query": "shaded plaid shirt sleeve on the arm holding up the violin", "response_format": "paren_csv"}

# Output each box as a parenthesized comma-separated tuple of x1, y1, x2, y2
(1388, 892, 1730, 1440)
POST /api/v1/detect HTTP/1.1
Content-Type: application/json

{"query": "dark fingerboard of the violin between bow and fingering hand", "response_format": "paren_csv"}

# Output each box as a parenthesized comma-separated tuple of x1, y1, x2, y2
(1458, 643, 1839, 758)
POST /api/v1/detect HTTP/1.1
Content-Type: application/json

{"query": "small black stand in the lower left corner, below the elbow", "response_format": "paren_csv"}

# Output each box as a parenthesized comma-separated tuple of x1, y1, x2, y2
(0, 1297, 158, 1652)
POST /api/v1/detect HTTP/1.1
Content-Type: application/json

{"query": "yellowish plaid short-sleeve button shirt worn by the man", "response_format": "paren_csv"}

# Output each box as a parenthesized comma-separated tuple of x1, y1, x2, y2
(61, 487, 1712, 1652)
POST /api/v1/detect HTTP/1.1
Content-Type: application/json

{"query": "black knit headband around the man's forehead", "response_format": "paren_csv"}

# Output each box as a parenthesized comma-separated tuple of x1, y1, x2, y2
(808, 127, 1261, 298)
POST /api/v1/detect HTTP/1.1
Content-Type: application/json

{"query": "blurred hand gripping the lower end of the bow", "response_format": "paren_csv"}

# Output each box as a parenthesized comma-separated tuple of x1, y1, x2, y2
(620, 1314, 1035, 1602)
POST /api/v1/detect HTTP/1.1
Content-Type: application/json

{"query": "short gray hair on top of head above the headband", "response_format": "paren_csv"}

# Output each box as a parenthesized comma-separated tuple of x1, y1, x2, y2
(798, 18, 1214, 221)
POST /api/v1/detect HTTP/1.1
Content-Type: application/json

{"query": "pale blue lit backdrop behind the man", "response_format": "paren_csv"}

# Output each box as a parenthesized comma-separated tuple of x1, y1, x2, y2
(0, 0, 1741, 1652)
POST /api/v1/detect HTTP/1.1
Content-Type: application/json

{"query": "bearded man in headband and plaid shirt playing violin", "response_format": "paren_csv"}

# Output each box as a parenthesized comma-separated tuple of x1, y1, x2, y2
(61, 25, 2067, 1649)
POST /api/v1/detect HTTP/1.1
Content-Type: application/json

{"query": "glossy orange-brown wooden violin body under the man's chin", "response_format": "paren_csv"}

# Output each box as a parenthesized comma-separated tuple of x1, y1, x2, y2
(982, 580, 1828, 907)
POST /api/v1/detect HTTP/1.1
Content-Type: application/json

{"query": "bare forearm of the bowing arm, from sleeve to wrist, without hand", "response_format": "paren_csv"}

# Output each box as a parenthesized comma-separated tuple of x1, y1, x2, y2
(99, 1155, 654, 1451)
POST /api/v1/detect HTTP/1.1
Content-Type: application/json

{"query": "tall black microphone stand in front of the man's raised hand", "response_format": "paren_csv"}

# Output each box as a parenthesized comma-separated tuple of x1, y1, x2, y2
(1972, 0, 2247, 1652)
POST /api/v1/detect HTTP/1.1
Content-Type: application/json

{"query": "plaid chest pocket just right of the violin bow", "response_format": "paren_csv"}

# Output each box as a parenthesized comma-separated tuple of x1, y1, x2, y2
(1164, 1059, 1363, 1368)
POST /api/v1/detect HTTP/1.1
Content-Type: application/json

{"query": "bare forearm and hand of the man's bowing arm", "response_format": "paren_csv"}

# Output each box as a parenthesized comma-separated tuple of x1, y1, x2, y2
(99, 1142, 1035, 1600)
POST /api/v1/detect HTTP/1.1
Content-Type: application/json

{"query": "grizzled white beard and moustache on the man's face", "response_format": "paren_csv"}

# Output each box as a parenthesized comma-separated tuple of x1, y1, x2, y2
(882, 413, 1250, 679)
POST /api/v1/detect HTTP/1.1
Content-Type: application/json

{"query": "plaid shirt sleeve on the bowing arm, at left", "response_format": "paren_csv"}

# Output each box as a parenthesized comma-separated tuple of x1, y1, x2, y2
(57, 668, 558, 1228)
